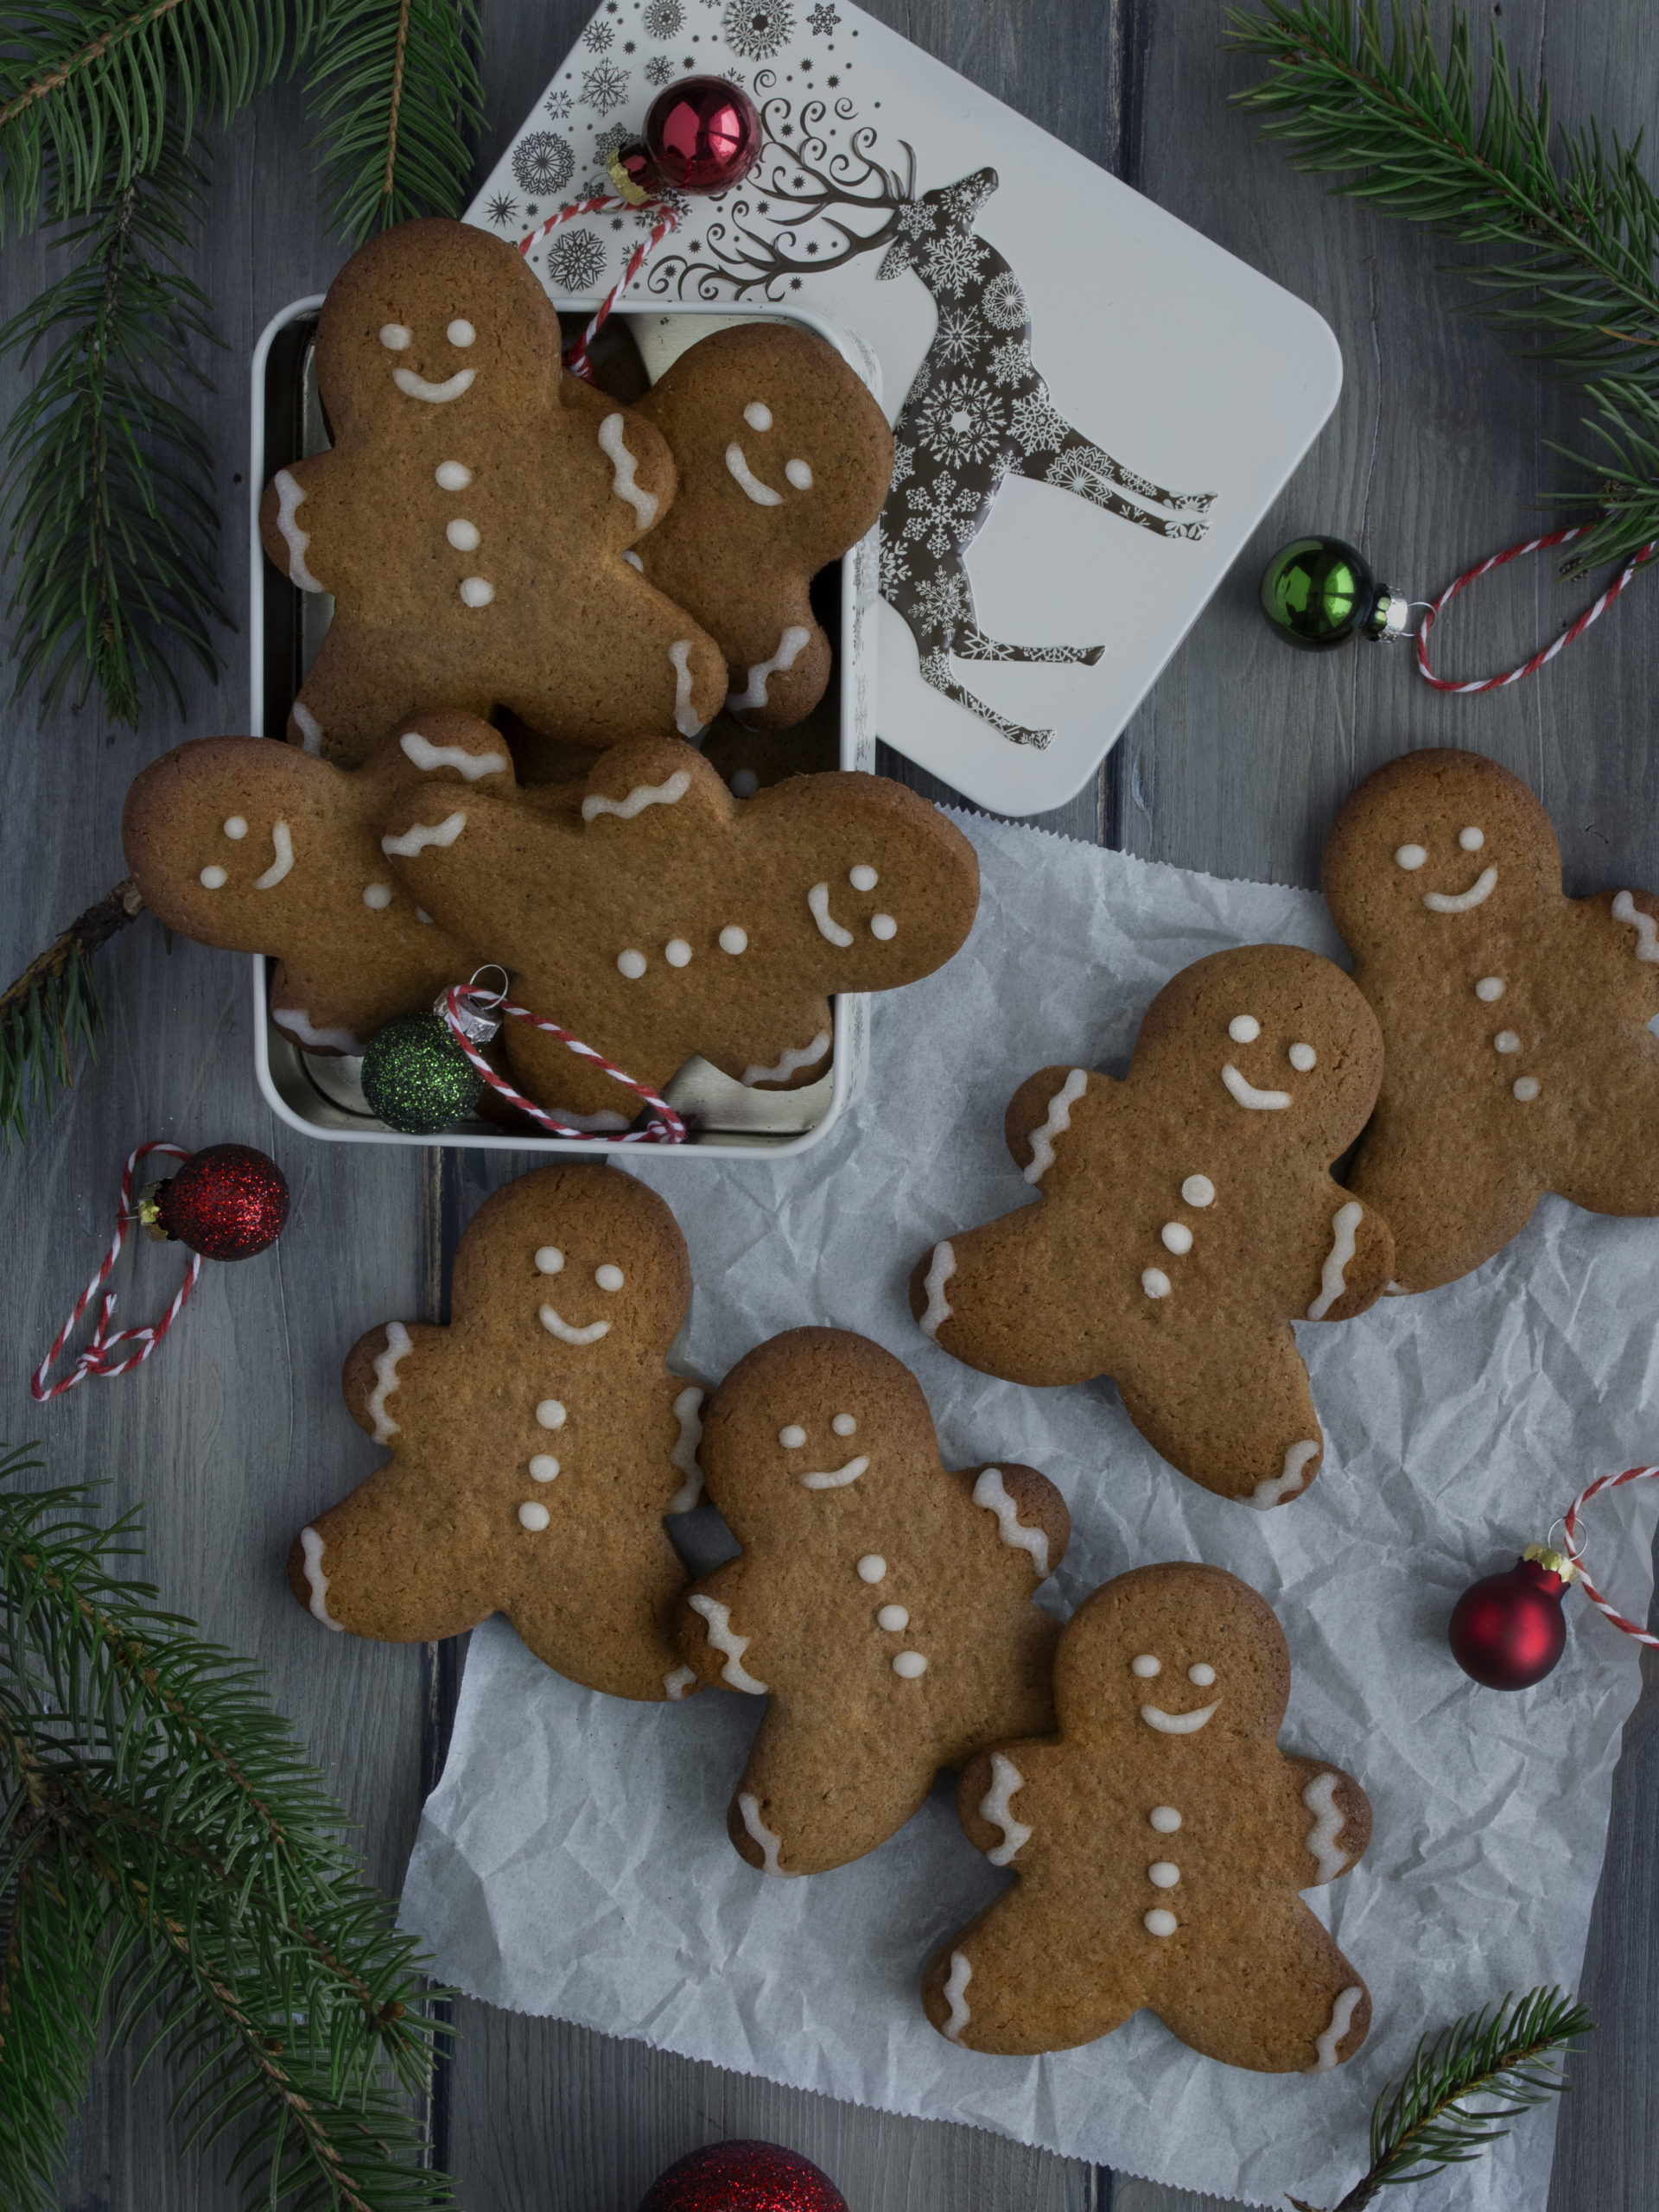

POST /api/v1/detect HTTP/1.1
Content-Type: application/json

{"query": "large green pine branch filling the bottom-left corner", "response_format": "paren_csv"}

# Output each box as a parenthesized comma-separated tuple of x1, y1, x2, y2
(0, 1453, 451, 2212)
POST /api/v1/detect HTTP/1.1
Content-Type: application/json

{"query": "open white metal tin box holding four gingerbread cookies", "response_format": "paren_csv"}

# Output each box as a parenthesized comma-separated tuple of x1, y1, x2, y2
(248, 294, 880, 1159)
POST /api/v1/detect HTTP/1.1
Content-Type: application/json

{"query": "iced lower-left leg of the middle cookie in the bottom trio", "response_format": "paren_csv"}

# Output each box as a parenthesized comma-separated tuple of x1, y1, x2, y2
(726, 1703, 936, 1873)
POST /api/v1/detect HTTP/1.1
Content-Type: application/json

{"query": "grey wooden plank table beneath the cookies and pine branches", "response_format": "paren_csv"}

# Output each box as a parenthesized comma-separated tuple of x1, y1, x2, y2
(0, 0, 1659, 2212)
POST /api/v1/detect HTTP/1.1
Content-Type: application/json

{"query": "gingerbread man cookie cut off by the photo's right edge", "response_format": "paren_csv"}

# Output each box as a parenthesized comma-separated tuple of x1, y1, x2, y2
(1325, 750, 1659, 1289)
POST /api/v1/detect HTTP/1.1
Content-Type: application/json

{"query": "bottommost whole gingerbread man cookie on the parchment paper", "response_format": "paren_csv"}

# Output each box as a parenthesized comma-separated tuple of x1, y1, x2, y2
(923, 1564, 1371, 2073)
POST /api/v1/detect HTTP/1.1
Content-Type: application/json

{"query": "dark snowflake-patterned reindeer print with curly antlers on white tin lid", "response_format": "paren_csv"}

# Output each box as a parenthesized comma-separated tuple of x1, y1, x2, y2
(651, 149, 1214, 747)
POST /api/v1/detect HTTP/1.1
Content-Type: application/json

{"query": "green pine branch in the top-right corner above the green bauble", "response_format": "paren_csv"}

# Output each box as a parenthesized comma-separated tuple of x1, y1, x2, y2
(1228, 0, 1659, 573)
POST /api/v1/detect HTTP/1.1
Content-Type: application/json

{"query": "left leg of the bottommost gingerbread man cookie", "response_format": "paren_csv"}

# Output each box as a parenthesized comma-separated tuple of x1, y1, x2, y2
(923, 1873, 1150, 2057)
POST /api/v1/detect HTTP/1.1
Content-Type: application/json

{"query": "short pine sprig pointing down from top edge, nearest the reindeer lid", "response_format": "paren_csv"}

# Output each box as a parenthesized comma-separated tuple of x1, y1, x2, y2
(309, 0, 485, 245)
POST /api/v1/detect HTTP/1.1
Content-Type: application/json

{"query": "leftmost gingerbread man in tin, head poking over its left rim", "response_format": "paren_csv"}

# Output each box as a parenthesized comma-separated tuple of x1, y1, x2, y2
(122, 715, 509, 1053)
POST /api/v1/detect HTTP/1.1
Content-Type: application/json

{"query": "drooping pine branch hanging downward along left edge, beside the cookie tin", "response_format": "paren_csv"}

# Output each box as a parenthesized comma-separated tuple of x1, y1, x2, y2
(0, 129, 230, 721)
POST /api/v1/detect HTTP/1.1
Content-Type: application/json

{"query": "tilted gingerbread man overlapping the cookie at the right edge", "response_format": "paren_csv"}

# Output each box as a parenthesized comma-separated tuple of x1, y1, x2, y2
(912, 944, 1394, 1506)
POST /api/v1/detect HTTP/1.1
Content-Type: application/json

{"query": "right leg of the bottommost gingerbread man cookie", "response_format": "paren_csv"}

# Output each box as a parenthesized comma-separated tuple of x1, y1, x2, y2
(1150, 1893, 1371, 2073)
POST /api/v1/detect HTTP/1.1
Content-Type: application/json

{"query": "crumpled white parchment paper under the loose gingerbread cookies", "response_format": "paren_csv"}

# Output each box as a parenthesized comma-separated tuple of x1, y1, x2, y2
(403, 818, 1659, 2212)
